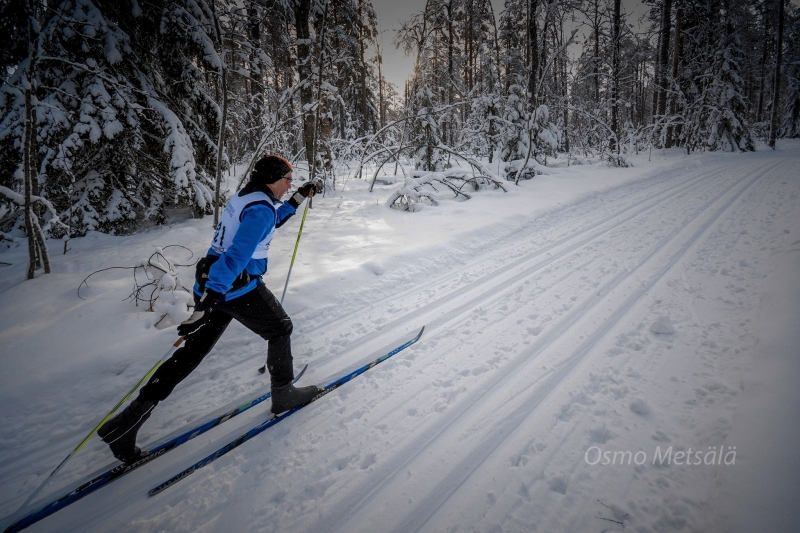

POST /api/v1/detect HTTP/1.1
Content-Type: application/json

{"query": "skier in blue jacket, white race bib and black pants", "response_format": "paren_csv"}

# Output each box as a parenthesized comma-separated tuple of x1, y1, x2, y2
(97, 155, 320, 463)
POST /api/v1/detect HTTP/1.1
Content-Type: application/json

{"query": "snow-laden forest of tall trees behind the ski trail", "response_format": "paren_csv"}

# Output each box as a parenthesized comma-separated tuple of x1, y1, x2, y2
(0, 0, 800, 278)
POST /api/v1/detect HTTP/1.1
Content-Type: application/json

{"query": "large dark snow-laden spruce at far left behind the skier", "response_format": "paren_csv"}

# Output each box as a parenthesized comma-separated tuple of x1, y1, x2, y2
(0, 0, 227, 241)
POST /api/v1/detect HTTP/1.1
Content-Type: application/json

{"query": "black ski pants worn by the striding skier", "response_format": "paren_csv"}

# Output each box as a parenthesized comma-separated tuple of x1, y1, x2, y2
(139, 284, 294, 402)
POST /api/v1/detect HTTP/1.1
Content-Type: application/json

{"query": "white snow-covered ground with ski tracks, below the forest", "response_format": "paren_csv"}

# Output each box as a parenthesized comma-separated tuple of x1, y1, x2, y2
(0, 141, 800, 533)
